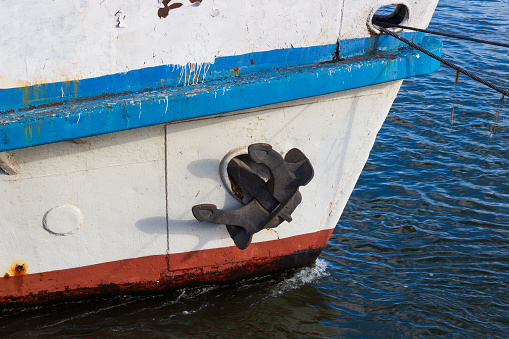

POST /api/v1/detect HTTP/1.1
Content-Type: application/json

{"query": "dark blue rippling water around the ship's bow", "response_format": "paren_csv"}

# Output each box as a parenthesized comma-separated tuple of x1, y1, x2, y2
(0, 0, 509, 338)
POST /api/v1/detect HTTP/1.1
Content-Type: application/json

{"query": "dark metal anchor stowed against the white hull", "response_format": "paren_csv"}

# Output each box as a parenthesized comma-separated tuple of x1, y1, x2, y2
(192, 143, 314, 250)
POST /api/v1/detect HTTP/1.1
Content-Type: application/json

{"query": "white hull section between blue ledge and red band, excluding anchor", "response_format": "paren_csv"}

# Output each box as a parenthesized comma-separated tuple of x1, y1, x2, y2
(0, 81, 401, 273)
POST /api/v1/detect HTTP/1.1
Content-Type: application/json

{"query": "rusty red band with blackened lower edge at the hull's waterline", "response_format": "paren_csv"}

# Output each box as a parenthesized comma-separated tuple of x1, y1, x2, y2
(0, 230, 333, 307)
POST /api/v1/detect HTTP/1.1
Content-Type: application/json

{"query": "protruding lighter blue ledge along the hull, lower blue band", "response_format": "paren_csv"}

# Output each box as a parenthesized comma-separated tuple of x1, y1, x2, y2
(0, 38, 442, 151)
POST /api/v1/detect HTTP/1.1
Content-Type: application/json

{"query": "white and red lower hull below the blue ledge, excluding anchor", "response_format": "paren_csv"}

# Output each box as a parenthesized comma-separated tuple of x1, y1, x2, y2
(0, 81, 401, 304)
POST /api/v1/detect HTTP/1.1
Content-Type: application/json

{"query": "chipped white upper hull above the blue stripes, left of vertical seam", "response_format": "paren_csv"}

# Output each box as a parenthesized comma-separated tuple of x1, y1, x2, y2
(0, 0, 341, 88)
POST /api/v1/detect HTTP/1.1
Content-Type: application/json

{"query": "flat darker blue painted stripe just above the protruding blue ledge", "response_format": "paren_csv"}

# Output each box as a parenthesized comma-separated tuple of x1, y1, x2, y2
(0, 33, 423, 113)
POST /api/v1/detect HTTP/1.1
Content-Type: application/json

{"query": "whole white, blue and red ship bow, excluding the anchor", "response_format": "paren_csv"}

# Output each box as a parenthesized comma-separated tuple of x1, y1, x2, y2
(0, 0, 439, 305)
